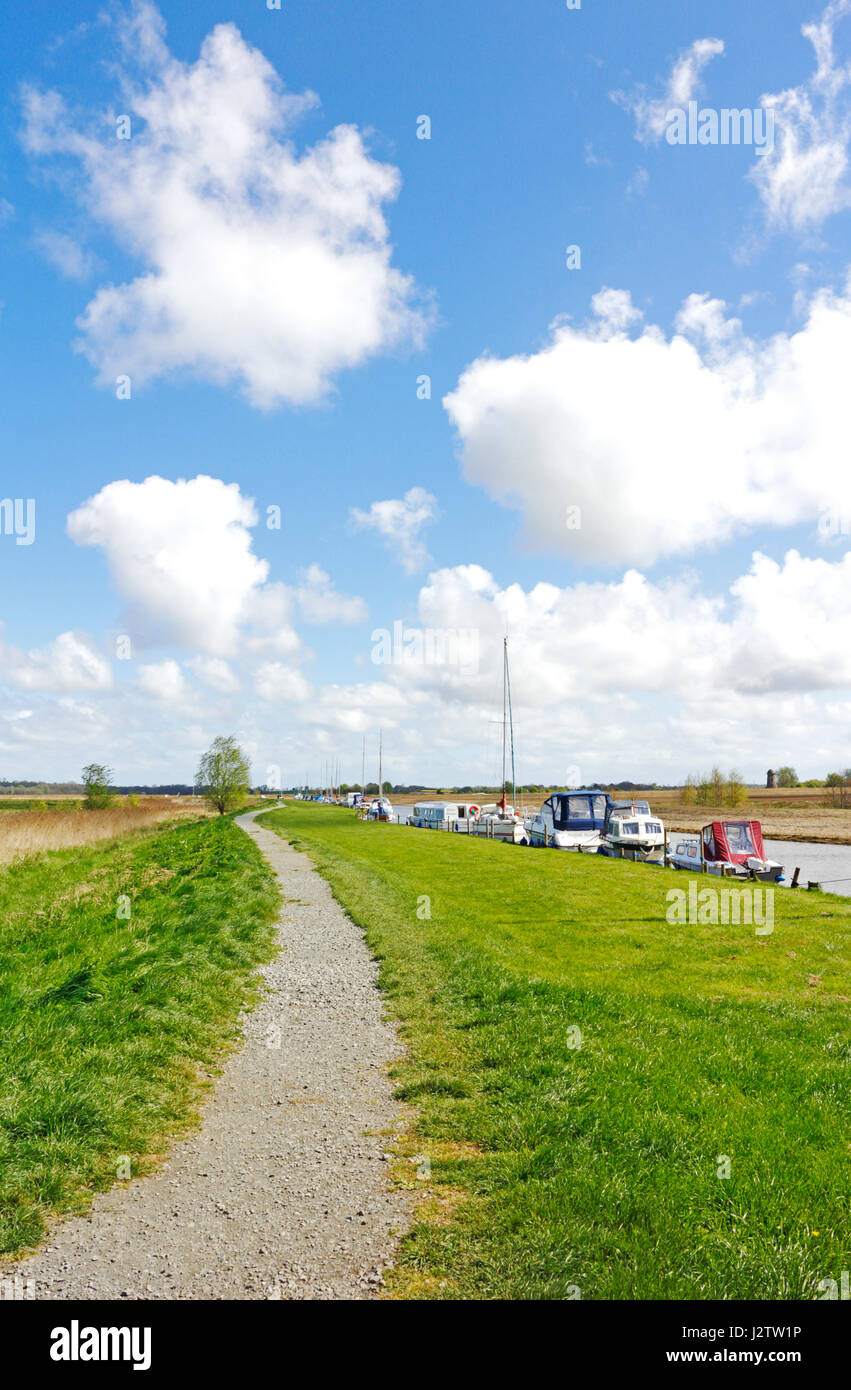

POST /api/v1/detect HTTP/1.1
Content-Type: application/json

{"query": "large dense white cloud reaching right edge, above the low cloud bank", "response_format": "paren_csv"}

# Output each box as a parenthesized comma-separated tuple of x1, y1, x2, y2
(444, 282, 851, 564)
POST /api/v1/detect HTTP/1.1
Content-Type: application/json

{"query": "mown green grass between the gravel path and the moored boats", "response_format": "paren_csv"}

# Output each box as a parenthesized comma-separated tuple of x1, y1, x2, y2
(263, 803, 851, 1300)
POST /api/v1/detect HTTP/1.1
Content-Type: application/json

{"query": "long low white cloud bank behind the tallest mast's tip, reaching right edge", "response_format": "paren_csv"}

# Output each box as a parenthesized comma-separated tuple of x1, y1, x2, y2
(411, 550, 851, 710)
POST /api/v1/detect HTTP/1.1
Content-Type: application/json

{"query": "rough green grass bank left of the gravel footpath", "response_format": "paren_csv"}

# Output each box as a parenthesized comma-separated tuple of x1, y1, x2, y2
(0, 817, 278, 1254)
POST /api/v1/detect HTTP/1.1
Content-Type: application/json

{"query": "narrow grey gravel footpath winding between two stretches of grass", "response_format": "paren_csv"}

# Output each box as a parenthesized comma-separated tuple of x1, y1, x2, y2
(3, 812, 410, 1298)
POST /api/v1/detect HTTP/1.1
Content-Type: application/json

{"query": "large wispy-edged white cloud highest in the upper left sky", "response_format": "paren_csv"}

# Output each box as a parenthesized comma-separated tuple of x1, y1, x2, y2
(25, 3, 428, 407)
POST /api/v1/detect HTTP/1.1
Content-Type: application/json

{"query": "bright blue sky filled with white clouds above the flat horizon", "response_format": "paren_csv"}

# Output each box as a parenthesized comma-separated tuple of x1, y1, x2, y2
(0, 0, 851, 784)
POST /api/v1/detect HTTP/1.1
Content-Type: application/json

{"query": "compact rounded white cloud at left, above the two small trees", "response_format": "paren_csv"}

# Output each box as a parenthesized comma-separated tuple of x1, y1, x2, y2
(68, 474, 268, 656)
